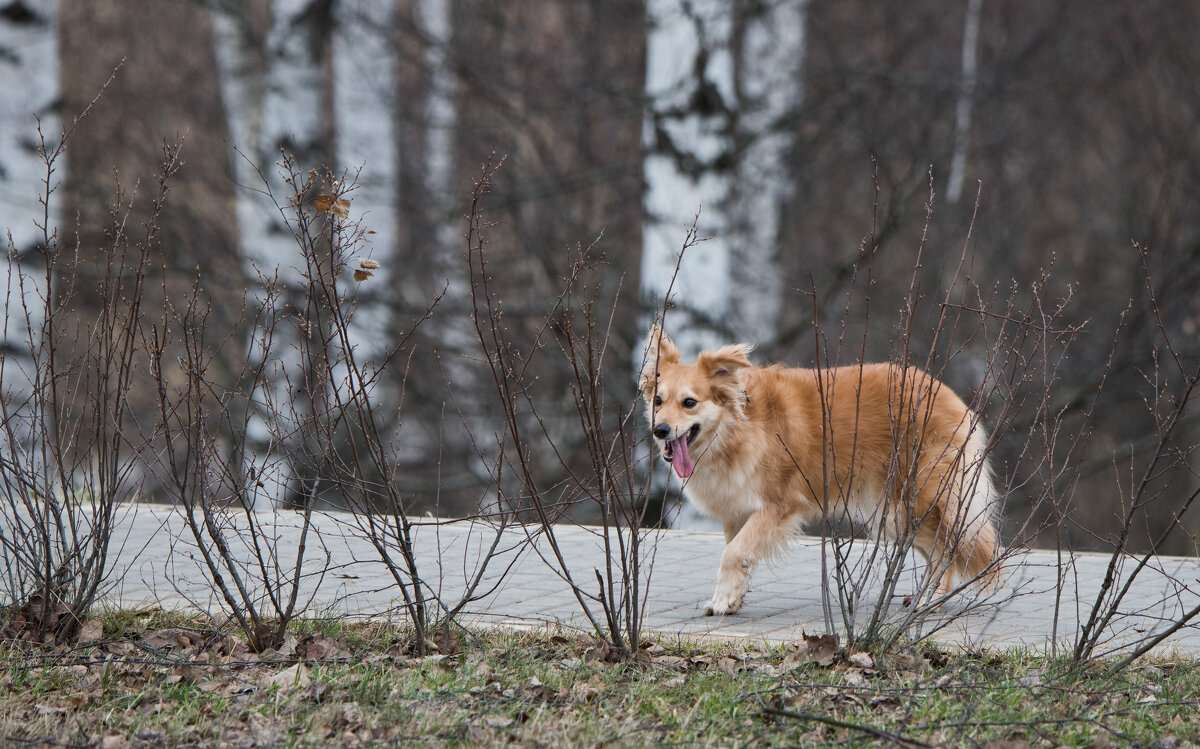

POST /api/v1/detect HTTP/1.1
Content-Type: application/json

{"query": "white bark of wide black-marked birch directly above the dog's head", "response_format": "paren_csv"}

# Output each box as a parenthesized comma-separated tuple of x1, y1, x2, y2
(642, 0, 804, 528)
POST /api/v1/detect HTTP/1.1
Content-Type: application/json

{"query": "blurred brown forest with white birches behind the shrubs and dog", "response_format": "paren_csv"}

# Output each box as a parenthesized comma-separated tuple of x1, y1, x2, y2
(0, 0, 1200, 552)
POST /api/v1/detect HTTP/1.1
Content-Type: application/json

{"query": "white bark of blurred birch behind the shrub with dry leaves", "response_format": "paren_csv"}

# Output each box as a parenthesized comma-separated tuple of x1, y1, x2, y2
(214, 0, 334, 505)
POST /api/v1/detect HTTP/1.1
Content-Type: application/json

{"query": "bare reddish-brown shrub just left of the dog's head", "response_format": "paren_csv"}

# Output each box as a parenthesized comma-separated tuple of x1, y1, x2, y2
(453, 156, 672, 658)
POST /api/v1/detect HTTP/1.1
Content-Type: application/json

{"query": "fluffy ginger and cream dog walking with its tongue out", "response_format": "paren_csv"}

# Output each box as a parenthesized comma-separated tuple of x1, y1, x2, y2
(640, 325, 1000, 616)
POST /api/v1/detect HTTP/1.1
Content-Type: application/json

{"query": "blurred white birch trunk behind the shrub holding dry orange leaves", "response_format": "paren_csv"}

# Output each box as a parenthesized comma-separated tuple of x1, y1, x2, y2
(212, 0, 337, 507)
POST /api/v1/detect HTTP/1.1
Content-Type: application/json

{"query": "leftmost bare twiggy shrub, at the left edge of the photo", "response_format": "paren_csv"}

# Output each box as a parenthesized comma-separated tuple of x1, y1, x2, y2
(0, 73, 154, 643)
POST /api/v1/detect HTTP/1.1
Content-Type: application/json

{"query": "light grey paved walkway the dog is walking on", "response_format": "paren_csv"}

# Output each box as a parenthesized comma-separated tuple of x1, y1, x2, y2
(100, 505, 1200, 653)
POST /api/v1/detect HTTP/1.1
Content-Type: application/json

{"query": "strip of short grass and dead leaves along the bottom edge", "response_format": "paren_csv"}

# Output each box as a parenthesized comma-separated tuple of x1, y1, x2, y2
(0, 610, 1200, 749)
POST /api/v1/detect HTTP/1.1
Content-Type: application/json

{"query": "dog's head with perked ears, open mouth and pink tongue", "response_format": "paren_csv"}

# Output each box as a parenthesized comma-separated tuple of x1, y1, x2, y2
(640, 325, 754, 479)
